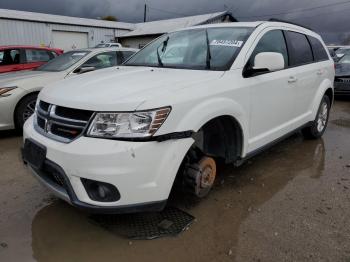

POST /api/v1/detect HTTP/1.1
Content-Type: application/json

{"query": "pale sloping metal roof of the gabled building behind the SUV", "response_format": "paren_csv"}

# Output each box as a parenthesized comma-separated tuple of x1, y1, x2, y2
(121, 11, 232, 37)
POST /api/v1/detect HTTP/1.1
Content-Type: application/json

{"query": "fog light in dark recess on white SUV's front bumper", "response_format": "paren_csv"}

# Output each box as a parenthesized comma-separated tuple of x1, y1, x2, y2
(81, 178, 120, 202)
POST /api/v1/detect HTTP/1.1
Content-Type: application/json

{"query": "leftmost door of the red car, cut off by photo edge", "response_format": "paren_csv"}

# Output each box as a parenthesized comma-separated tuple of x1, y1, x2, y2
(0, 48, 23, 73)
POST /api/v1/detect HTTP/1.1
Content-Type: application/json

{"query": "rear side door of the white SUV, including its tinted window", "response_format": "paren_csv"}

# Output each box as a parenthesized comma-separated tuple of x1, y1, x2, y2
(285, 31, 319, 121)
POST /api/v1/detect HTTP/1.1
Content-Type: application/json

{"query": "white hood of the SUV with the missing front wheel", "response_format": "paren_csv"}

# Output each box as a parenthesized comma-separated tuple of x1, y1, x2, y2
(39, 66, 223, 111)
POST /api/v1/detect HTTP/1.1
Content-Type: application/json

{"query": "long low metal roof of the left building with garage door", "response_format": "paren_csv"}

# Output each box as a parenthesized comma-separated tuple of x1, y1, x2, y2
(0, 9, 135, 30)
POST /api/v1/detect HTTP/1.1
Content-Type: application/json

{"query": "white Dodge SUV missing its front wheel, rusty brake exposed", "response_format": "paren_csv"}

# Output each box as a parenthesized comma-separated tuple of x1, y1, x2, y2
(22, 22, 334, 213)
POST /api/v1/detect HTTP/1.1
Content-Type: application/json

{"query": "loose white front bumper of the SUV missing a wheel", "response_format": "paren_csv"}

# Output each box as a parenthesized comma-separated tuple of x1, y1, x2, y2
(23, 117, 193, 213)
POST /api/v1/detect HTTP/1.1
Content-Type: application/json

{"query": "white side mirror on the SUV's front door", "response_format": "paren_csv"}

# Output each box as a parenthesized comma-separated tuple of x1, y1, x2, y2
(253, 52, 284, 72)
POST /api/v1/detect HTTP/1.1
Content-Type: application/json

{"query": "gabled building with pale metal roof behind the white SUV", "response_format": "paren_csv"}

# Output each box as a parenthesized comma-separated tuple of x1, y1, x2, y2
(118, 11, 237, 48)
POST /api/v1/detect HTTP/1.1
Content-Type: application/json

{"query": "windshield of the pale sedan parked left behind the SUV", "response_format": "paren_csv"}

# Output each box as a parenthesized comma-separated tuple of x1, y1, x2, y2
(36, 51, 90, 72)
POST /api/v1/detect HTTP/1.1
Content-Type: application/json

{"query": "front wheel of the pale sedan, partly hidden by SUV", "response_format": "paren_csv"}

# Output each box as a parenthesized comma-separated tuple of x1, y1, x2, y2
(14, 94, 38, 131)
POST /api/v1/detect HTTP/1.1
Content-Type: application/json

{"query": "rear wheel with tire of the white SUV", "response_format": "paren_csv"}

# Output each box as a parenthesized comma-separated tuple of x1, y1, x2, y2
(301, 96, 331, 139)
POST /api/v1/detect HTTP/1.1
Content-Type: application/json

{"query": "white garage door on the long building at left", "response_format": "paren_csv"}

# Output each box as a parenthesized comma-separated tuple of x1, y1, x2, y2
(52, 31, 89, 51)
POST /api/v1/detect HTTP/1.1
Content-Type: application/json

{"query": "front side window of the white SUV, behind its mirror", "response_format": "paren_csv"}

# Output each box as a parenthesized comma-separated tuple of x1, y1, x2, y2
(248, 30, 288, 68)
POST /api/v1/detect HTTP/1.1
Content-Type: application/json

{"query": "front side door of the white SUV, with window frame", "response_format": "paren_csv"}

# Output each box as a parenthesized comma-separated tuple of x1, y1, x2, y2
(245, 29, 295, 151)
